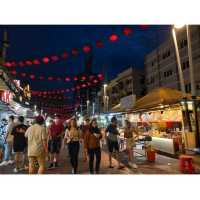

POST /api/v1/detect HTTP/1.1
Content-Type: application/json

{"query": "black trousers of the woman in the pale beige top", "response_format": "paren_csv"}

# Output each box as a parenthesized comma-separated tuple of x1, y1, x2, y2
(68, 142, 80, 174)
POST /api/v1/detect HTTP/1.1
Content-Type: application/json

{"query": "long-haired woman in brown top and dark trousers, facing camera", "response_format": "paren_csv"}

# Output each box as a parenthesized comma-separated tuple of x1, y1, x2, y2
(85, 119, 102, 174)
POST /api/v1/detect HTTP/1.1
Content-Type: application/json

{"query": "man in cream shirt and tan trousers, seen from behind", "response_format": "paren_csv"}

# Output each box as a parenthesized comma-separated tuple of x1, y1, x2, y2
(25, 116, 48, 174)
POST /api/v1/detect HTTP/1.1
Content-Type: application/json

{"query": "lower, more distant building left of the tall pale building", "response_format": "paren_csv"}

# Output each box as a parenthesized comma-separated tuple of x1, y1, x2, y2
(99, 67, 145, 112)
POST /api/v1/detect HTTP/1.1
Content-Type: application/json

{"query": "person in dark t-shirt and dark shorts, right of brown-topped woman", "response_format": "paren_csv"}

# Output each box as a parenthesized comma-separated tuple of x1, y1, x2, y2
(106, 117, 124, 169)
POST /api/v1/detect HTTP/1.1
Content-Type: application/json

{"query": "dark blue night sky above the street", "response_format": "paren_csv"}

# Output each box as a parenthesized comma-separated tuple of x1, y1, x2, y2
(0, 25, 170, 94)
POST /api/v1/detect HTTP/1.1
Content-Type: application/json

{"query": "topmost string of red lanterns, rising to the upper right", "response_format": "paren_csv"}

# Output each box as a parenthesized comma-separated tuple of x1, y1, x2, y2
(3, 25, 139, 68)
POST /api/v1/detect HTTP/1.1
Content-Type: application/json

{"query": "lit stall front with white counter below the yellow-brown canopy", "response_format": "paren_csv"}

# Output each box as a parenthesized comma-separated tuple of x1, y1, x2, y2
(127, 106, 184, 155)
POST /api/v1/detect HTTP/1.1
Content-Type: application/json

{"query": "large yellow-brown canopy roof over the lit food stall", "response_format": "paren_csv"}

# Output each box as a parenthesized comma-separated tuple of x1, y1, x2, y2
(134, 88, 191, 110)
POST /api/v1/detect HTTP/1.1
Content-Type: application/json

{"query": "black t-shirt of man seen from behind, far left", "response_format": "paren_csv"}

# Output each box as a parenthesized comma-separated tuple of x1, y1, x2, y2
(11, 124, 27, 151)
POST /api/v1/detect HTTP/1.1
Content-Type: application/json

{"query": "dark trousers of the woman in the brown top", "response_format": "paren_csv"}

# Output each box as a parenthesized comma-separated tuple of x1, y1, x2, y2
(88, 148, 101, 174)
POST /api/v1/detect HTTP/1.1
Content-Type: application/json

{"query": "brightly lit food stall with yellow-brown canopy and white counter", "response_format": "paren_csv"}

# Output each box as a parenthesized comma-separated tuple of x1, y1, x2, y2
(126, 88, 198, 155)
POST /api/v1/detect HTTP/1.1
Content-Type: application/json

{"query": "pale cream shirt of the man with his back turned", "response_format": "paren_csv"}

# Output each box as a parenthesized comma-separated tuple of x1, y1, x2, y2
(25, 124, 47, 156)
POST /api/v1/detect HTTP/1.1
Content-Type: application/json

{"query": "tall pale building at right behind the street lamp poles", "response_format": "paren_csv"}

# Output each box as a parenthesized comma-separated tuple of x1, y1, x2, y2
(145, 25, 200, 95)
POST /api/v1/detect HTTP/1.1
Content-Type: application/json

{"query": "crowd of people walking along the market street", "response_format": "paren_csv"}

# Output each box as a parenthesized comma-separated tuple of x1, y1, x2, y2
(0, 113, 137, 174)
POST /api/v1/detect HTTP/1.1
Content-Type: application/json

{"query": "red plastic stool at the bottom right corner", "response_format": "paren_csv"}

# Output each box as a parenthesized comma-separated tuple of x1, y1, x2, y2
(179, 155, 195, 174)
